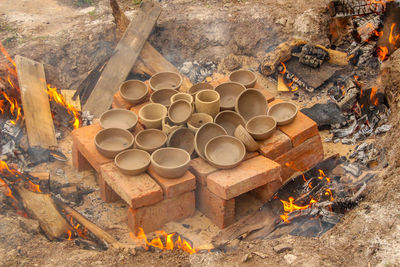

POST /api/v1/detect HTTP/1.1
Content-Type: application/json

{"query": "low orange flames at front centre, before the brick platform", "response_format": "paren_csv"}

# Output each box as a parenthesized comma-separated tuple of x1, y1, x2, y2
(129, 227, 197, 254)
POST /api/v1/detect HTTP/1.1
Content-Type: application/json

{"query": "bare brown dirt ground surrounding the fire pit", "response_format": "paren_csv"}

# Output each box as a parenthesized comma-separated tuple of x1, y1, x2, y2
(0, 0, 400, 266)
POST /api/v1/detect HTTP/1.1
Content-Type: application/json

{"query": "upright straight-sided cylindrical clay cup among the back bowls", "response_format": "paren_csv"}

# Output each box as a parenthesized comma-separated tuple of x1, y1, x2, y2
(195, 90, 220, 117)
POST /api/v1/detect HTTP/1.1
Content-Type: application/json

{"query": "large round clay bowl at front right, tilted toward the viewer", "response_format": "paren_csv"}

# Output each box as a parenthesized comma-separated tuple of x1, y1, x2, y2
(205, 135, 246, 169)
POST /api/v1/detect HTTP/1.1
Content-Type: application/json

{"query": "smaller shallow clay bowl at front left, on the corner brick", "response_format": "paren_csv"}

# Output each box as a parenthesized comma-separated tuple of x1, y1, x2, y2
(114, 149, 150, 175)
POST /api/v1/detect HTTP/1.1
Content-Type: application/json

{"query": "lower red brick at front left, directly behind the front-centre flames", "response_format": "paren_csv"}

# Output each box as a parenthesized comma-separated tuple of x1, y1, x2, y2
(128, 192, 195, 235)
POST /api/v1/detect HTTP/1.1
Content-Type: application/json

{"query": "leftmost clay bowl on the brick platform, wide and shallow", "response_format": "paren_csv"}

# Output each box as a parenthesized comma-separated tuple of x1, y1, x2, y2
(94, 128, 135, 158)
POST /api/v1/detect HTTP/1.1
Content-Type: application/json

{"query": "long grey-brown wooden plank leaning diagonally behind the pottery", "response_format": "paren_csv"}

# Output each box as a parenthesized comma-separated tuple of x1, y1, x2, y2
(83, 1, 161, 118)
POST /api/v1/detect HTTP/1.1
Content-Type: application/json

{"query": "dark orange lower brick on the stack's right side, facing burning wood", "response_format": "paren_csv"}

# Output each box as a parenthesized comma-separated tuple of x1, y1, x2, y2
(275, 135, 324, 182)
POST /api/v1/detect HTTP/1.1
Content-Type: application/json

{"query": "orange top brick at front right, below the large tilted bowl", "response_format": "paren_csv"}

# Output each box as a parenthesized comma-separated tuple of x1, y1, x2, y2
(207, 156, 281, 199)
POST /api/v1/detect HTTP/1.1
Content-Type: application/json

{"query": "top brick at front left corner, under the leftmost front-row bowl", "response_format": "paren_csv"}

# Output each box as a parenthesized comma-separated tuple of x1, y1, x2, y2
(100, 162, 163, 208)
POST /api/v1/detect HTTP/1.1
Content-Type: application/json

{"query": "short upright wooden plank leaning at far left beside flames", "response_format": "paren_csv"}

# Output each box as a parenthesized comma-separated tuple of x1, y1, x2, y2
(15, 56, 57, 148)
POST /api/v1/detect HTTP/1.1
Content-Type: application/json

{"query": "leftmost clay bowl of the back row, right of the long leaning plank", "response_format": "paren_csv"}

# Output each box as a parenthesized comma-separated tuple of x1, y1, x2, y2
(119, 80, 149, 104)
